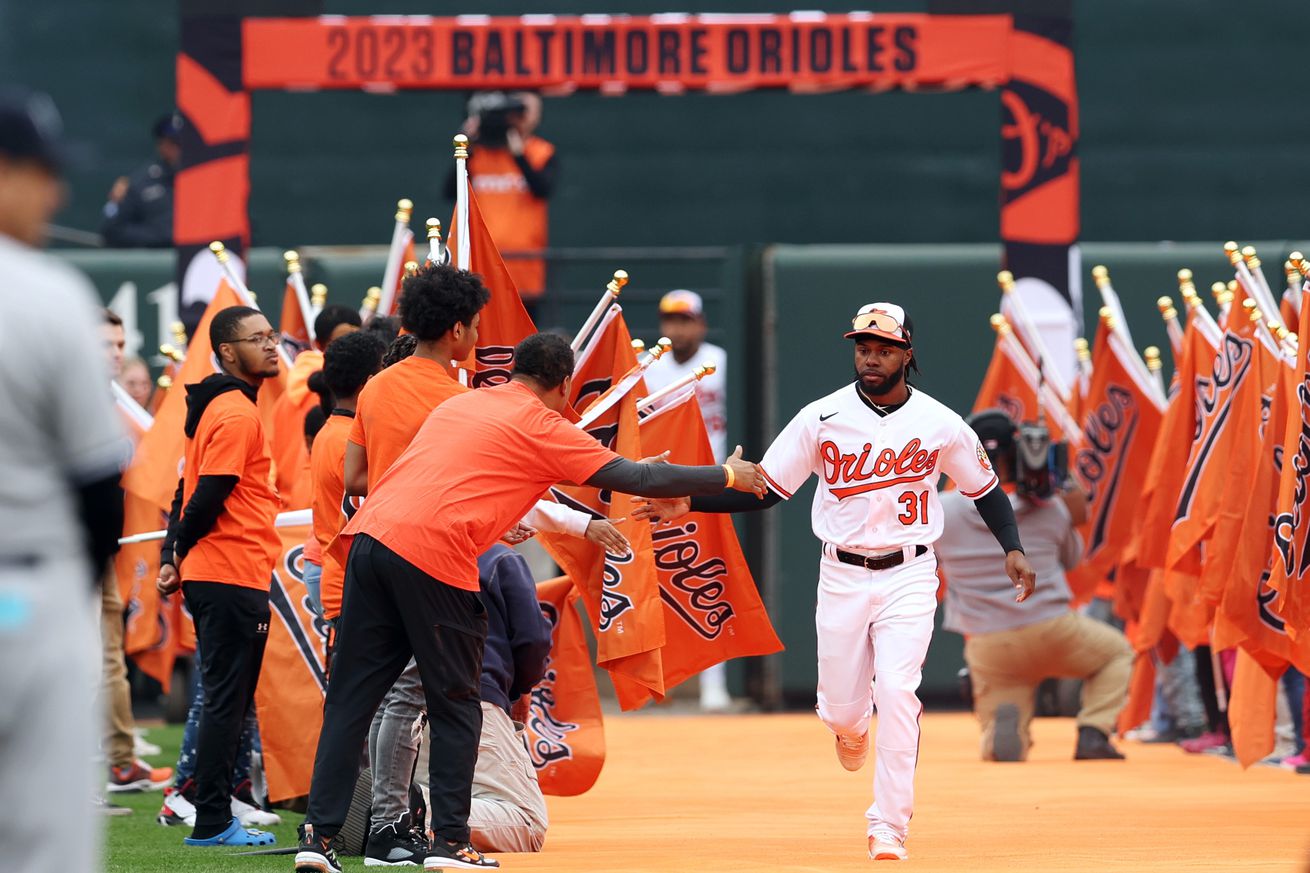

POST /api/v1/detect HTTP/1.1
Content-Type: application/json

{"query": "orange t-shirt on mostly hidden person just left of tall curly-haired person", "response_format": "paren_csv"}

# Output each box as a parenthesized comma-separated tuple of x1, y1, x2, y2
(309, 414, 356, 619)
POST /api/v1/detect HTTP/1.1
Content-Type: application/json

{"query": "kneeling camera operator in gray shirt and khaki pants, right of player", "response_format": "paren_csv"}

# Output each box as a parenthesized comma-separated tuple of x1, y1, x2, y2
(934, 409, 1133, 762)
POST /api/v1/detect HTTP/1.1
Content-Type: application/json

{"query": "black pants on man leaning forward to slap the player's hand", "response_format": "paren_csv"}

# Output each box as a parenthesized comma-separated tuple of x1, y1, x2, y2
(305, 535, 487, 842)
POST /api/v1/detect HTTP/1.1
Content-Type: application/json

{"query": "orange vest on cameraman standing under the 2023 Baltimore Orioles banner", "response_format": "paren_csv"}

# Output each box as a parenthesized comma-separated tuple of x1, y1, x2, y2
(469, 136, 555, 298)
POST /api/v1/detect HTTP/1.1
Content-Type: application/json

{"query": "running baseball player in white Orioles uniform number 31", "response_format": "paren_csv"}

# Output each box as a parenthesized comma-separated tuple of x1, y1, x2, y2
(635, 303, 1035, 860)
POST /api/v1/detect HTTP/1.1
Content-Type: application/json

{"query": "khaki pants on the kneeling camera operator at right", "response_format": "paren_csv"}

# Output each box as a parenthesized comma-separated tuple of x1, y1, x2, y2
(964, 612, 1133, 759)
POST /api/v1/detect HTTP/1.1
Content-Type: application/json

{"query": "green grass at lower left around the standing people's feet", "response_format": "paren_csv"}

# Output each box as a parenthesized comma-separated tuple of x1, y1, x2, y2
(105, 726, 306, 873)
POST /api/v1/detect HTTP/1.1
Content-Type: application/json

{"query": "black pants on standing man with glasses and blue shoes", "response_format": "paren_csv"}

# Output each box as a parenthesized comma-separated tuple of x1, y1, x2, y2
(182, 582, 269, 836)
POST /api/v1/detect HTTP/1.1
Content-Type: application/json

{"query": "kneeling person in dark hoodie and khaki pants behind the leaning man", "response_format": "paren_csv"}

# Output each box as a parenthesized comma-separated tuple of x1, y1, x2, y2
(466, 544, 550, 852)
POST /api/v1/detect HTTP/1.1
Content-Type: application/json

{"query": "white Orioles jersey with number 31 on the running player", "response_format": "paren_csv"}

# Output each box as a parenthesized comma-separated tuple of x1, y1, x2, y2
(760, 383, 997, 553)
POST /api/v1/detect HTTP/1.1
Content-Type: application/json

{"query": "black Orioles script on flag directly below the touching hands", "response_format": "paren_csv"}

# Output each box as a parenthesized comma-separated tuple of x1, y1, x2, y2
(651, 522, 732, 640)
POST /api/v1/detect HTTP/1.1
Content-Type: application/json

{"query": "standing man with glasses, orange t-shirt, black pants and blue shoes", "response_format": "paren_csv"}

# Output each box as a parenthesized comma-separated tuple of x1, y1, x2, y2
(157, 307, 282, 845)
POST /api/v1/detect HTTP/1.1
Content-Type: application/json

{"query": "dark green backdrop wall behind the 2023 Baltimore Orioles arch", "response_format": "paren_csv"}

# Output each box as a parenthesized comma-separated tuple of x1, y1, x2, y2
(0, 0, 1310, 246)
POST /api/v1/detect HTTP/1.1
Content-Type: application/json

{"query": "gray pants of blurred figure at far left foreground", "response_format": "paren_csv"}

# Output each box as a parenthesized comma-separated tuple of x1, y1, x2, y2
(0, 558, 103, 873)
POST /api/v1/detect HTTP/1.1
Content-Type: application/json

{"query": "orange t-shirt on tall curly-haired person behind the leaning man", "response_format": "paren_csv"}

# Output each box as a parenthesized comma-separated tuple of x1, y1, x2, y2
(350, 357, 469, 494)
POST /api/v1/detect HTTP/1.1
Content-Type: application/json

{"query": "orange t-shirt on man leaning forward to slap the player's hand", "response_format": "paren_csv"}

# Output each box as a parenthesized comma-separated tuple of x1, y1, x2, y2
(346, 381, 618, 591)
